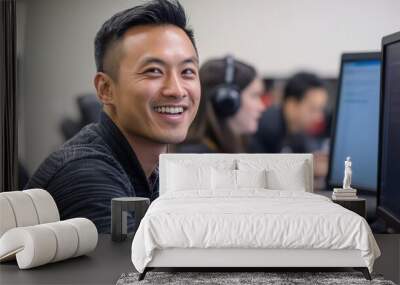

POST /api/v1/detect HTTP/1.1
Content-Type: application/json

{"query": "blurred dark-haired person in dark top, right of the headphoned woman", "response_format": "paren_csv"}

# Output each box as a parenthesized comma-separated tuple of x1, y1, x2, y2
(250, 72, 328, 153)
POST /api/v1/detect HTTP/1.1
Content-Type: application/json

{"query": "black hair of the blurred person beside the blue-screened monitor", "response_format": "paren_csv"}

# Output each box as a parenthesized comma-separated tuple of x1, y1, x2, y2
(283, 72, 325, 102)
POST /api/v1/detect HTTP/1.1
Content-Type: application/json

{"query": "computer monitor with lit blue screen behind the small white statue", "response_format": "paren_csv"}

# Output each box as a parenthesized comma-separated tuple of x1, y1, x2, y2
(327, 52, 381, 191)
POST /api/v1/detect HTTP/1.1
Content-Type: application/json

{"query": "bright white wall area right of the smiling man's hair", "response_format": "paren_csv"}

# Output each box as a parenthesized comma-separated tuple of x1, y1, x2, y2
(182, 0, 400, 76)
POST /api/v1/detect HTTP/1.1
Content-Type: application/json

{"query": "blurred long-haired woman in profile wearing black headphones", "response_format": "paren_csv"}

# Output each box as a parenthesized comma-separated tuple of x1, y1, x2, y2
(176, 56, 264, 153)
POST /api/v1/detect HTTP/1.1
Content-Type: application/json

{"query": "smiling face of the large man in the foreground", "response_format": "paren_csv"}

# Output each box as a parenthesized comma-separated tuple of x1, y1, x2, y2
(106, 25, 201, 144)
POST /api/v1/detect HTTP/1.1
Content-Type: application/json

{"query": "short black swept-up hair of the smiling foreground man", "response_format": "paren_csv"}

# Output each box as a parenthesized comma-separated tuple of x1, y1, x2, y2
(94, 0, 197, 75)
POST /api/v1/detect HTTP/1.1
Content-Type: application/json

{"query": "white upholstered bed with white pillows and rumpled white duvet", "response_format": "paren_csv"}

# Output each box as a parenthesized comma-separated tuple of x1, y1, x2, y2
(132, 154, 380, 278)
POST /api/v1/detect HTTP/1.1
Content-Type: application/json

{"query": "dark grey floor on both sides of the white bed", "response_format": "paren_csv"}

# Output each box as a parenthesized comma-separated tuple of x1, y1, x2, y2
(0, 234, 400, 285)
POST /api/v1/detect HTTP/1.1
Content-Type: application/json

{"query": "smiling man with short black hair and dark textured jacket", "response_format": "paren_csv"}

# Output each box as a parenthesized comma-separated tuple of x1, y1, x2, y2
(25, 0, 200, 232)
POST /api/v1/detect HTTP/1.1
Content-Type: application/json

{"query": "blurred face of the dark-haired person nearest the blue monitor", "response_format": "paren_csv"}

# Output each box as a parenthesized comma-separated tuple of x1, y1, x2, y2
(296, 88, 328, 131)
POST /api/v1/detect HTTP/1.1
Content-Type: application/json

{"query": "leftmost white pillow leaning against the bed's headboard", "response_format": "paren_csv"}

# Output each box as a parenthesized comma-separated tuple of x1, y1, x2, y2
(167, 163, 211, 191)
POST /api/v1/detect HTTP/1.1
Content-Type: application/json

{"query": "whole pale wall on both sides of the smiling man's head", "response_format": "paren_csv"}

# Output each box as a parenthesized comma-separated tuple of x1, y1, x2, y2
(18, 0, 400, 173)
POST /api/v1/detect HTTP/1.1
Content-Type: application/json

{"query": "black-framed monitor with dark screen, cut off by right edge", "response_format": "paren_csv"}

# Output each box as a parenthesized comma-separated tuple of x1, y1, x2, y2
(377, 32, 400, 232)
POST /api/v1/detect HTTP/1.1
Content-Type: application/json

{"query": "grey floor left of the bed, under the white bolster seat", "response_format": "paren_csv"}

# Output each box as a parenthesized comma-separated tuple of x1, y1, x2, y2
(0, 235, 135, 285)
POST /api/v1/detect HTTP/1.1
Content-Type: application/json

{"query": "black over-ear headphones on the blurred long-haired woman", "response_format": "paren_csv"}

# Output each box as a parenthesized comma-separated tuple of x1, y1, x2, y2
(211, 55, 240, 118)
